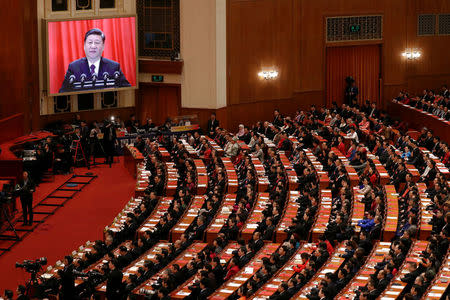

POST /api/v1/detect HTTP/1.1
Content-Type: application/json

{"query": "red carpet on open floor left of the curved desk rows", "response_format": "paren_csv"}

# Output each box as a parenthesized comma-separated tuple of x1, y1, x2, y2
(0, 158, 136, 295)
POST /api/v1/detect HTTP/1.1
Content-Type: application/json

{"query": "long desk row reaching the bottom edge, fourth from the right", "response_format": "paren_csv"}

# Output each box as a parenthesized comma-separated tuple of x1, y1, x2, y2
(292, 244, 345, 299)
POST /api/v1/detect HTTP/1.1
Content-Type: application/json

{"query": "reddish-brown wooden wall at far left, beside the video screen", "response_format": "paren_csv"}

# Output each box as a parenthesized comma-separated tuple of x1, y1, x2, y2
(0, 0, 39, 132)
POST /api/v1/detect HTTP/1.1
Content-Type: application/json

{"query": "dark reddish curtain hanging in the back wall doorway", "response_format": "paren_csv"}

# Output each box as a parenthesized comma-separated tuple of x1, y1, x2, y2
(327, 45, 381, 106)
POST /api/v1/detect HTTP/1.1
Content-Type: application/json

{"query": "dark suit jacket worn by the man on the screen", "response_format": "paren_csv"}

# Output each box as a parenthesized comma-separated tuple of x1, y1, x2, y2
(59, 57, 131, 93)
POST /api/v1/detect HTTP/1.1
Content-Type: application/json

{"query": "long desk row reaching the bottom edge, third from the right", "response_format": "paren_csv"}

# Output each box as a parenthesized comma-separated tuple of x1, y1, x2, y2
(335, 242, 391, 300)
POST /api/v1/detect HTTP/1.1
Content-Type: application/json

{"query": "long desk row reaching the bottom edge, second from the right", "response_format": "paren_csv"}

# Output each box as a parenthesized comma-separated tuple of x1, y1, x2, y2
(380, 241, 428, 300)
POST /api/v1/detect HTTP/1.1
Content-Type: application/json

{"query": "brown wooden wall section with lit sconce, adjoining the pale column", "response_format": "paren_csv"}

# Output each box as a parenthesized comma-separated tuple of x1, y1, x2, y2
(227, 0, 294, 105)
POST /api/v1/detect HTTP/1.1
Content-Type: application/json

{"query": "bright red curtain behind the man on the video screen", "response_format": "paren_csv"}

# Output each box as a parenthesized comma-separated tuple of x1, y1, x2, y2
(48, 17, 136, 94)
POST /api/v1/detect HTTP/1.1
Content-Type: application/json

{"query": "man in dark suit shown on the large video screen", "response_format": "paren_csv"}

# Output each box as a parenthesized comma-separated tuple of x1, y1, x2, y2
(59, 28, 131, 93)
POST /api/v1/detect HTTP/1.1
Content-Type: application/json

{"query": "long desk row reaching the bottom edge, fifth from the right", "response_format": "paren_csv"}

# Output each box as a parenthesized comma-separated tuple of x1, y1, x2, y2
(249, 243, 316, 300)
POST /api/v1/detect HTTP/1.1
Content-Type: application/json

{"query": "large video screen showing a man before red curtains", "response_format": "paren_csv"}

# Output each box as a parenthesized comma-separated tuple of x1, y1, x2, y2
(47, 16, 137, 96)
